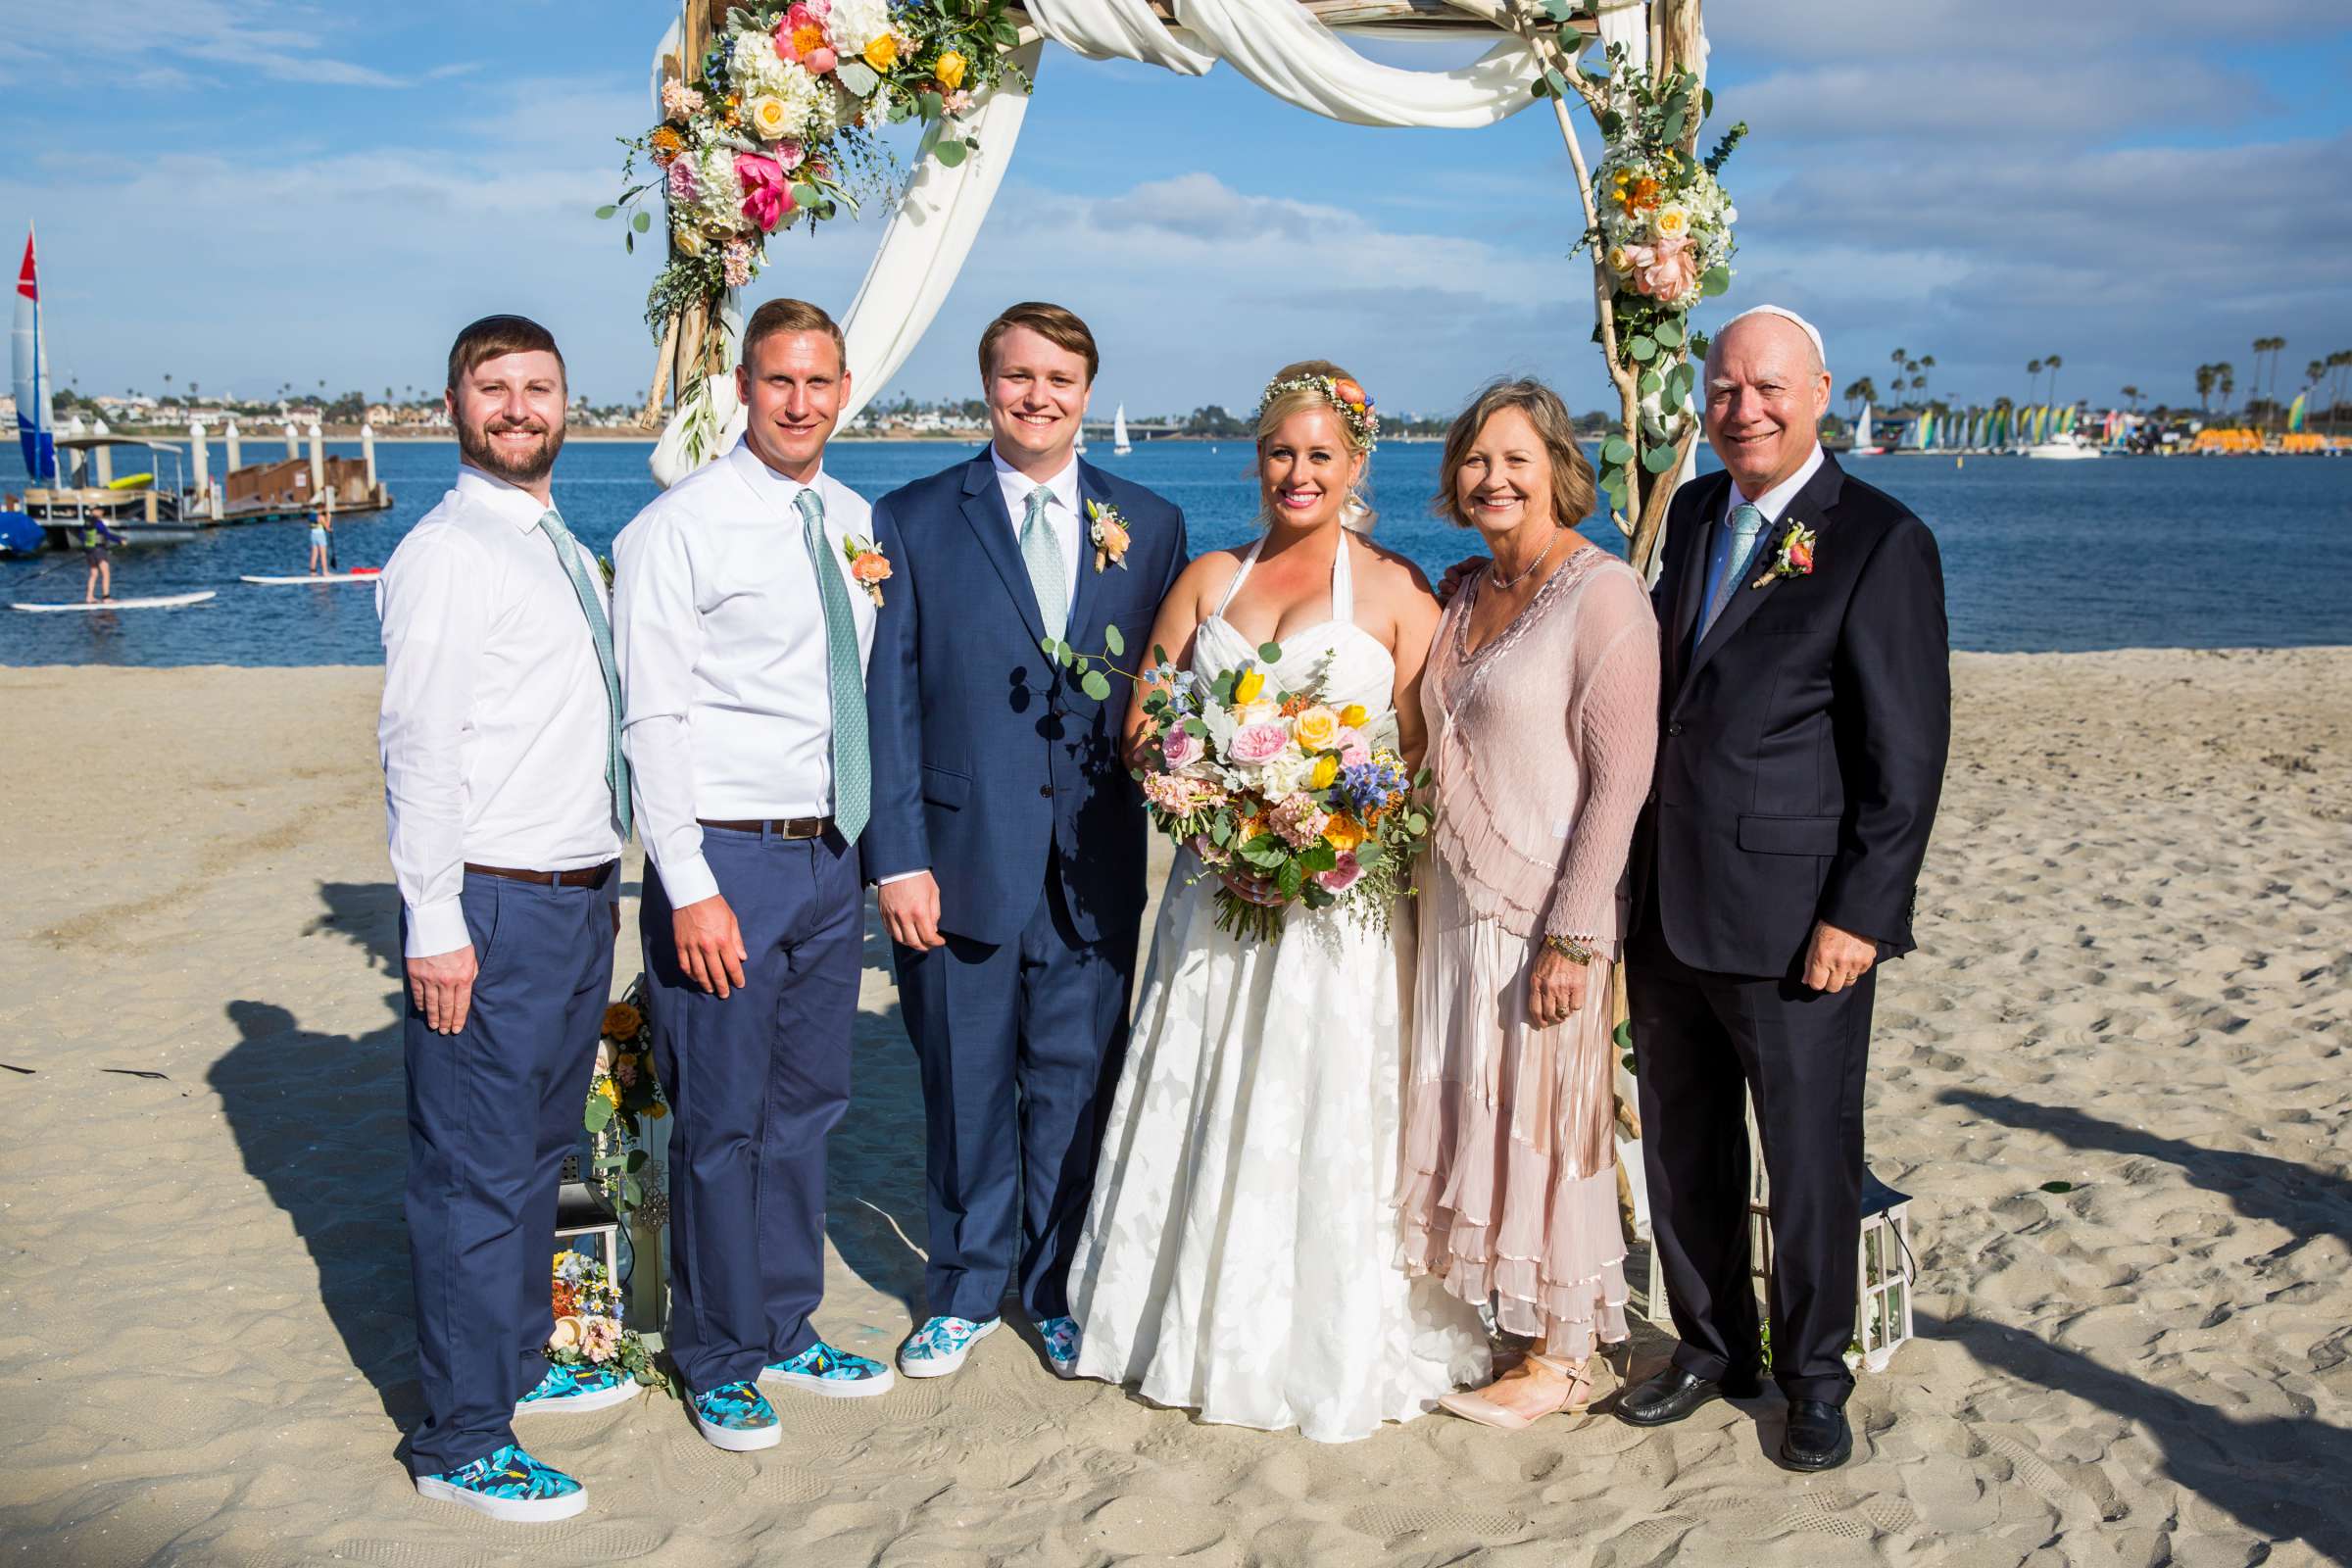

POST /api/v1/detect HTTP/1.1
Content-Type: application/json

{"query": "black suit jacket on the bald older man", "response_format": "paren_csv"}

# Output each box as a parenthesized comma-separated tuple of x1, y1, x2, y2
(1633, 454, 1952, 976)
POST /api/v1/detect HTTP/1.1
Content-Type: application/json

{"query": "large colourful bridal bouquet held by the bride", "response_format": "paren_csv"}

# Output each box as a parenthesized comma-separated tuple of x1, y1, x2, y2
(1136, 647, 1430, 941)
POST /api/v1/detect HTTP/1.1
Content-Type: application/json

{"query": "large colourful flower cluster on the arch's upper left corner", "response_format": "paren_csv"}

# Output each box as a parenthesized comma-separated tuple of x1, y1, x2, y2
(615, 0, 1025, 336)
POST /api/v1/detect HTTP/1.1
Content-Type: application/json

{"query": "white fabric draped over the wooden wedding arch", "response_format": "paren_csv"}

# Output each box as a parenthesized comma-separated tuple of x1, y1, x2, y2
(652, 0, 1561, 484)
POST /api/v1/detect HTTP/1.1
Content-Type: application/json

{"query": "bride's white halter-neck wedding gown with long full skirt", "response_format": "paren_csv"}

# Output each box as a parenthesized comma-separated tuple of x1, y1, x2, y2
(1070, 541, 1489, 1444)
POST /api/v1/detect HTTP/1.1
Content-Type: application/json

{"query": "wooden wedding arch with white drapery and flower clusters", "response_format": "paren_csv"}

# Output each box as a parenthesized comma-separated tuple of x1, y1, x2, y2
(600, 0, 1745, 1259)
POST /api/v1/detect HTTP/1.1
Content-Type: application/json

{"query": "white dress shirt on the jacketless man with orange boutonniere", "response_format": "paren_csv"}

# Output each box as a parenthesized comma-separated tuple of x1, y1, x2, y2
(612, 440, 889, 907)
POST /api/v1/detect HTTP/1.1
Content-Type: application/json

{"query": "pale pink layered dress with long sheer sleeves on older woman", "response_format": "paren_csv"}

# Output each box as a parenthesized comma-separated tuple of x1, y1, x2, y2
(1397, 550, 1658, 1359)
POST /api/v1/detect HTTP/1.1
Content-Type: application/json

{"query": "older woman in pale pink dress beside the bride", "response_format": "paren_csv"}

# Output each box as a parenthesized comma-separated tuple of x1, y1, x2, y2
(1399, 381, 1658, 1427)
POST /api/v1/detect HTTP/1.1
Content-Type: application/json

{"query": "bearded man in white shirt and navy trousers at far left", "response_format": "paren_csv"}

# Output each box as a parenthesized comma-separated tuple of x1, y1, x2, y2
(376, 315, 635, 1521)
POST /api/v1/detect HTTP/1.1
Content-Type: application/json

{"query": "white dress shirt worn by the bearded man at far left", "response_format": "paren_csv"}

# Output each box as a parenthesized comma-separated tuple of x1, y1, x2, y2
(376, 467, 621, 959)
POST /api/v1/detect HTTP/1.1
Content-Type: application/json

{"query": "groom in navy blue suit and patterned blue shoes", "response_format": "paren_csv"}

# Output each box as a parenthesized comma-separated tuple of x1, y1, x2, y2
(863, 303, 1186, 1378)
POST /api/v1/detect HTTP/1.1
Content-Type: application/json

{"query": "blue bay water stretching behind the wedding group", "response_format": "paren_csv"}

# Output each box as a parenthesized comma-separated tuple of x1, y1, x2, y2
(0, 440, 2352, 665)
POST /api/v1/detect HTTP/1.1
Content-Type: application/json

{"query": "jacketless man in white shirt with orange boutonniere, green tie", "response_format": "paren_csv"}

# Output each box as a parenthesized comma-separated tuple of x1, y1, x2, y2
(613, 299, 894, 1450)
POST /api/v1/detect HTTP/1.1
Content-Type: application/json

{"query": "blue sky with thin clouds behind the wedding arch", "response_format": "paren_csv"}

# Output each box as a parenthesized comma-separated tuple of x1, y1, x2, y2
(0, 0, 2352, 412)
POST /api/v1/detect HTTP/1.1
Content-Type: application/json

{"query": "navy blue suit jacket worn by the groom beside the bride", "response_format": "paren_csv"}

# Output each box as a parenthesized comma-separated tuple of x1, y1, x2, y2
(860, 449, 1186, 945)
